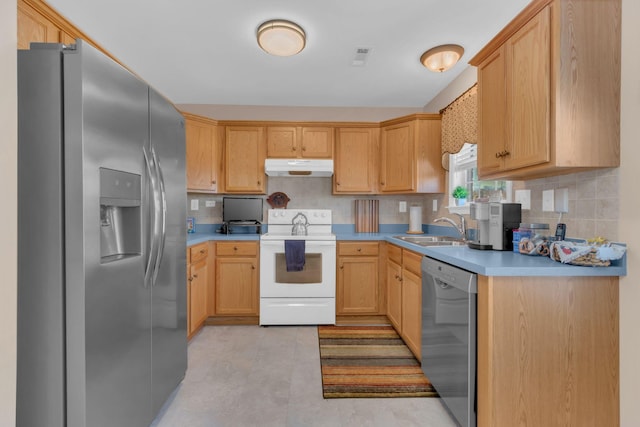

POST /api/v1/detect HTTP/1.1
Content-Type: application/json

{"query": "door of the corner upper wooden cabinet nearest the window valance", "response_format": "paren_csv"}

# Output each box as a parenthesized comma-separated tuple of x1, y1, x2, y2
(380, 122, 416, 193)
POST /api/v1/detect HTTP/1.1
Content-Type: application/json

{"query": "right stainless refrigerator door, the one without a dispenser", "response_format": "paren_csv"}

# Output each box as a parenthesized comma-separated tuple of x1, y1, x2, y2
(148, 89, 187, 414)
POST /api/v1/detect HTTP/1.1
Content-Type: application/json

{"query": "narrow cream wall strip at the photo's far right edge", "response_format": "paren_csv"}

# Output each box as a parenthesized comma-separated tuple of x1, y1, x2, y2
(619, 0, 640, 427)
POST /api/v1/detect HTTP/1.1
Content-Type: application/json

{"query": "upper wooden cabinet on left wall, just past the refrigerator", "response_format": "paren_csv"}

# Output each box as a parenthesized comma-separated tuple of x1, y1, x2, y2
(183, 113, 221, 193)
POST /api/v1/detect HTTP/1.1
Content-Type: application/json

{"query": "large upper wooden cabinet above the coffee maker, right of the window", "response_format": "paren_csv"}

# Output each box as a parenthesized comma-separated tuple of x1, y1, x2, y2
(470, 0, 621, 179)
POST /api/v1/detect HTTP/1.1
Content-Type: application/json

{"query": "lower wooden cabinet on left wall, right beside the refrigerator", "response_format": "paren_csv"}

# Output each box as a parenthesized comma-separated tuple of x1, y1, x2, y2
(187, 243, 209, 337)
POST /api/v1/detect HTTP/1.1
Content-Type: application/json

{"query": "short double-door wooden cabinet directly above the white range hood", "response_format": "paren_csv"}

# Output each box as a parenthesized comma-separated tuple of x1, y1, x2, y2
(267, 126, 333, 159)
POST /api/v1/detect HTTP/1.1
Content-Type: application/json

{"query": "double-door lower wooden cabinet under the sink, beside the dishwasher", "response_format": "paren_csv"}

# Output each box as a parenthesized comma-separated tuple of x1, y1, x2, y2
(387, 245, 423, 360)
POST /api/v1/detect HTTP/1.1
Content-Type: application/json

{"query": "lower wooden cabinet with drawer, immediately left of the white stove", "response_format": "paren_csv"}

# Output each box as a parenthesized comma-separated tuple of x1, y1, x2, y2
(215, 241, 260, 316)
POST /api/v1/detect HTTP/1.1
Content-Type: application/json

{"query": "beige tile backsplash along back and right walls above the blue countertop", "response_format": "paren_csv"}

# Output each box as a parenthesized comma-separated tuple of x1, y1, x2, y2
(187, 168, 624, 240)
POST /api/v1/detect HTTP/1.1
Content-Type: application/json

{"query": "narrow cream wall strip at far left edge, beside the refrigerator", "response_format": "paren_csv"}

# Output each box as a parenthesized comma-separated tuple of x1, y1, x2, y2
(0, 1, 17, 426)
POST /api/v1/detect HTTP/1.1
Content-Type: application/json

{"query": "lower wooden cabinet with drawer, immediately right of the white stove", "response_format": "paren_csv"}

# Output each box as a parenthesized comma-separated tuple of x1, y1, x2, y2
(336, 242, 383, 315)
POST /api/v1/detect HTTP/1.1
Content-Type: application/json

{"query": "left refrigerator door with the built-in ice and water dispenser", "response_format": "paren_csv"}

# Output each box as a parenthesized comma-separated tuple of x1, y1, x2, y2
(63, 41, 152, 426)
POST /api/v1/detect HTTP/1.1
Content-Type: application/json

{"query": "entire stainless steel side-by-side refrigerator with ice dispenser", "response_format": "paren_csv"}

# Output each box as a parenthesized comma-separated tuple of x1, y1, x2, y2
(17, 40, 187, 427)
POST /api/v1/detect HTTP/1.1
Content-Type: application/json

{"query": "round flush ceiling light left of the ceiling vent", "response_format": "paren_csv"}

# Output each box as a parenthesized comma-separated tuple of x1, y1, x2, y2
(257, 19, 306, 56)
